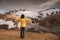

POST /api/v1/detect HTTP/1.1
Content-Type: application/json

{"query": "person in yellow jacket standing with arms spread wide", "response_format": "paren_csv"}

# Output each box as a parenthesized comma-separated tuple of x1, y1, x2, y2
(15, 14, 32, 38)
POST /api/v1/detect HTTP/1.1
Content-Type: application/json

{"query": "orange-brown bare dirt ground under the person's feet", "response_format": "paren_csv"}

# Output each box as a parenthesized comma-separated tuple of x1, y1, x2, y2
(0, 29, 58, 40)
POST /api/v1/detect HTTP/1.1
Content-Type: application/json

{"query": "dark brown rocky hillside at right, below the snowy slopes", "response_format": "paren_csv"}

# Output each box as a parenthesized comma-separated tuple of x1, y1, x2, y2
(39, 14, 60, 34)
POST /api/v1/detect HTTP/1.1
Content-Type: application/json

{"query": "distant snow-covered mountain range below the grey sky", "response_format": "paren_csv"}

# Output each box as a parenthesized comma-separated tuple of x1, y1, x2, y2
(0, 8, 60, 18)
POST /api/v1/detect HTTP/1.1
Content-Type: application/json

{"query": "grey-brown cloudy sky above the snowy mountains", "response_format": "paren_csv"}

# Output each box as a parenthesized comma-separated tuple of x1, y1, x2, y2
(0, 0, 60, 11)
